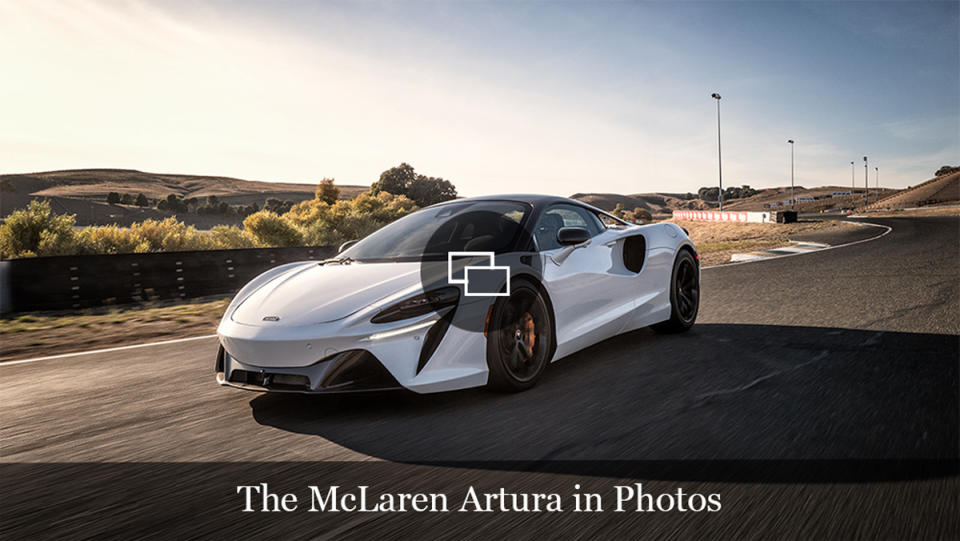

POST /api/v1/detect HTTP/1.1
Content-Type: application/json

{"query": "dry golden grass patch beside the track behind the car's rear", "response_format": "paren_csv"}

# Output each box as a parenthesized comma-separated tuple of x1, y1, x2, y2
(672, 216, 857, 265)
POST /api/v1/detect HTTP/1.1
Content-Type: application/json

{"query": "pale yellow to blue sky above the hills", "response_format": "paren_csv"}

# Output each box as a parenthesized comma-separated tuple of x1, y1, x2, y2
(0, 0, 960, 196)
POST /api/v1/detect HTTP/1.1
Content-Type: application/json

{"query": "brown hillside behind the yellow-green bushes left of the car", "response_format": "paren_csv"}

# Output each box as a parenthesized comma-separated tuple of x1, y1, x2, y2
(0, 169, 369, 228)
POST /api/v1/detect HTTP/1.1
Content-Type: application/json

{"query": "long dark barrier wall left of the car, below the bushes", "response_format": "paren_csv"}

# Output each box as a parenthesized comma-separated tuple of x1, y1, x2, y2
(0, 246, 336, 313)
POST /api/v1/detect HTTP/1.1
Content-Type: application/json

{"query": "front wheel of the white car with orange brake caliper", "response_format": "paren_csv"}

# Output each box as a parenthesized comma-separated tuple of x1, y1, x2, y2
(487, 280, 553, 392)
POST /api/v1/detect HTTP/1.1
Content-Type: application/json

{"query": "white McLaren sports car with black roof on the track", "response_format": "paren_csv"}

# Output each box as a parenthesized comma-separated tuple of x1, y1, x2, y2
(216, 195, 700, 393)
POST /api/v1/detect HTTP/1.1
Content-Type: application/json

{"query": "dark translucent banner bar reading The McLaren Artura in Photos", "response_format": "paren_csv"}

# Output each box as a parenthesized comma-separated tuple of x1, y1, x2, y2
(0, 460, 960, 539)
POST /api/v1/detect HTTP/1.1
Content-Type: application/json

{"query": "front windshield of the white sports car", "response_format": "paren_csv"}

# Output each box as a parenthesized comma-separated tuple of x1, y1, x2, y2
(337, 201, 530, 261)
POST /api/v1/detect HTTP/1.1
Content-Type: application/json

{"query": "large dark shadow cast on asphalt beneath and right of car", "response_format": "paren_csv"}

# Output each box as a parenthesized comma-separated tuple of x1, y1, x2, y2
(250, 324, 960, 482)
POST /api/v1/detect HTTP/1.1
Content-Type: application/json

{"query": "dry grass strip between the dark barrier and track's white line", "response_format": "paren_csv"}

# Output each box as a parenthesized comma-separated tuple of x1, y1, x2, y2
(0, 299, 230, 361)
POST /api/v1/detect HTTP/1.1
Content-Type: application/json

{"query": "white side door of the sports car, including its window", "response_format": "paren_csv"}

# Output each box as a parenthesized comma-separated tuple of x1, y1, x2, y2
(534, 203, 633, 358)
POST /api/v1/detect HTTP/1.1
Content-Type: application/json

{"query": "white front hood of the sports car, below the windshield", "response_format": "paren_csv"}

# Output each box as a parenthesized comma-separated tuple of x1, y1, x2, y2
(230, 262, 420, 327)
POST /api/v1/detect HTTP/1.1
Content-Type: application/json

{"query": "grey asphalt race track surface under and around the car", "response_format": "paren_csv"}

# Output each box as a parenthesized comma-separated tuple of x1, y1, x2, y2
(0, 217, 960, 539)
